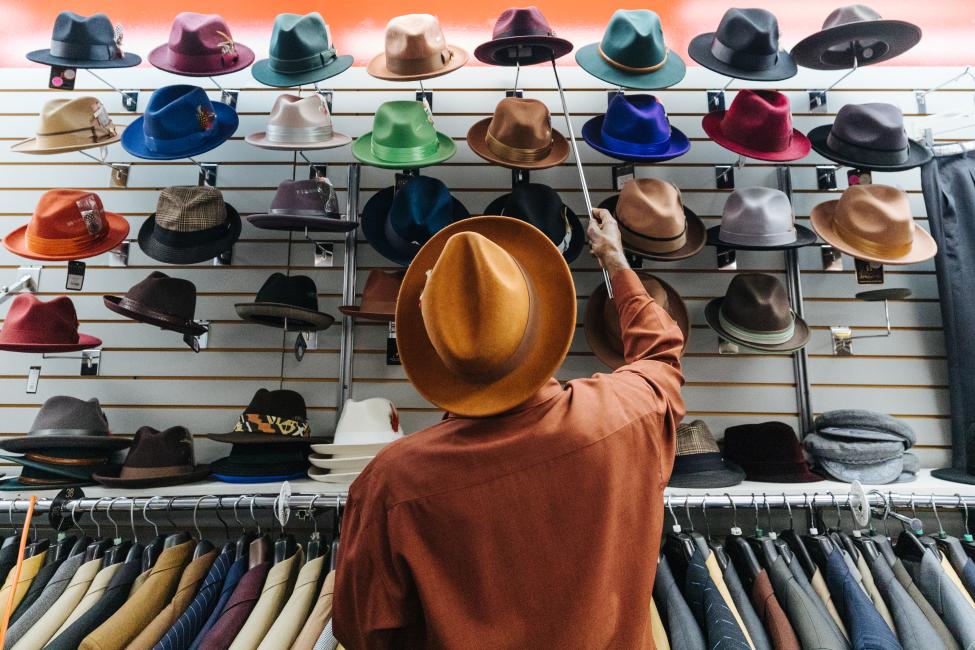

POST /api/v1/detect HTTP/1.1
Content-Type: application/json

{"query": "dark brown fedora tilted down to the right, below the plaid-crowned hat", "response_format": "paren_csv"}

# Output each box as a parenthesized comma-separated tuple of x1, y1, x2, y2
(103, 271, 207, 336)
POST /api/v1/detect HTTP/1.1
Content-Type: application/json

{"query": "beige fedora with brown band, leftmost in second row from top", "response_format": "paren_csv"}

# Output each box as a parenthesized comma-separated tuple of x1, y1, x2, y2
(10, 97, 121, 154)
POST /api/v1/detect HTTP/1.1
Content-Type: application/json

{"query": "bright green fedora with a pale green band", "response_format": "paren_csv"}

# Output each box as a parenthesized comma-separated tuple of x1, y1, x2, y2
(352, 101, 457, 169)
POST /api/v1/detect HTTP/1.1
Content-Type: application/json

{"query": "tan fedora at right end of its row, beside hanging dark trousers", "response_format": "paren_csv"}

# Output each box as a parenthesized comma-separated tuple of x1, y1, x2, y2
(809, 185, 938, 264)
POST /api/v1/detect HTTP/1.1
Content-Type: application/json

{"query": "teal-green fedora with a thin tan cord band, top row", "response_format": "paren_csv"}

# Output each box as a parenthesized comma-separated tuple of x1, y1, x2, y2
(576, 9, 687, 90)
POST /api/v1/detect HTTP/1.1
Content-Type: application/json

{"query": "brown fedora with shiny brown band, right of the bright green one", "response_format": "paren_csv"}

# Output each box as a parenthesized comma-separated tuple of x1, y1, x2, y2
(467, 97, 569, 169)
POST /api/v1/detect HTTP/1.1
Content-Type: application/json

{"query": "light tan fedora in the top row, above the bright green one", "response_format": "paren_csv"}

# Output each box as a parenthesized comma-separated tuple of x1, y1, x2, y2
(366, 14, 468, 81)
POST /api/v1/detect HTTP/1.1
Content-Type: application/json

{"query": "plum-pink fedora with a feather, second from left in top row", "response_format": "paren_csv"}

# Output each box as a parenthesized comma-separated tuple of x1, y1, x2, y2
(149, 11, 254, 77)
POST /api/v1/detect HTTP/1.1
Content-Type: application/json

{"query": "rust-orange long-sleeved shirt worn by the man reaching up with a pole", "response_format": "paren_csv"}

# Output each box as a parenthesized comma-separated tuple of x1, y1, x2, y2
(333, 270, 684, 649)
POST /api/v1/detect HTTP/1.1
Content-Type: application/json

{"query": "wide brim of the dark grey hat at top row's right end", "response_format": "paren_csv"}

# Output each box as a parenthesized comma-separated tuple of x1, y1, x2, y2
(792, 20, 921, 70)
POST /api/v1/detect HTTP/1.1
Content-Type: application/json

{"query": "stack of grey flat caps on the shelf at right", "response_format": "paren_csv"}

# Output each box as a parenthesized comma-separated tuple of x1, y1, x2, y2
(803, 409, 920, 485)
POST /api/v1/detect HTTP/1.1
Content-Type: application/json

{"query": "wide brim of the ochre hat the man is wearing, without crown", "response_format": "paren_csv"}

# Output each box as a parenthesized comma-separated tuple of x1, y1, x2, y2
(398, 217, 576, 416)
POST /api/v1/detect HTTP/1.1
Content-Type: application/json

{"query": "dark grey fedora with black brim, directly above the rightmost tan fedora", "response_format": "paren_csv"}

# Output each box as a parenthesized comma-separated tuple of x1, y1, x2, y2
(809, 103, 932, 171)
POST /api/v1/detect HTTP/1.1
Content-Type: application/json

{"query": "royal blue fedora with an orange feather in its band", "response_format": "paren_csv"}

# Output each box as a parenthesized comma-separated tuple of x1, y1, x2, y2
(122, 85, 239, 160)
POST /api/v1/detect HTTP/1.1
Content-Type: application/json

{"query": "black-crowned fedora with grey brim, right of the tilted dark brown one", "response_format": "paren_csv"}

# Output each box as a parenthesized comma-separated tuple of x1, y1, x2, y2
(234, 273, 335, 332)
